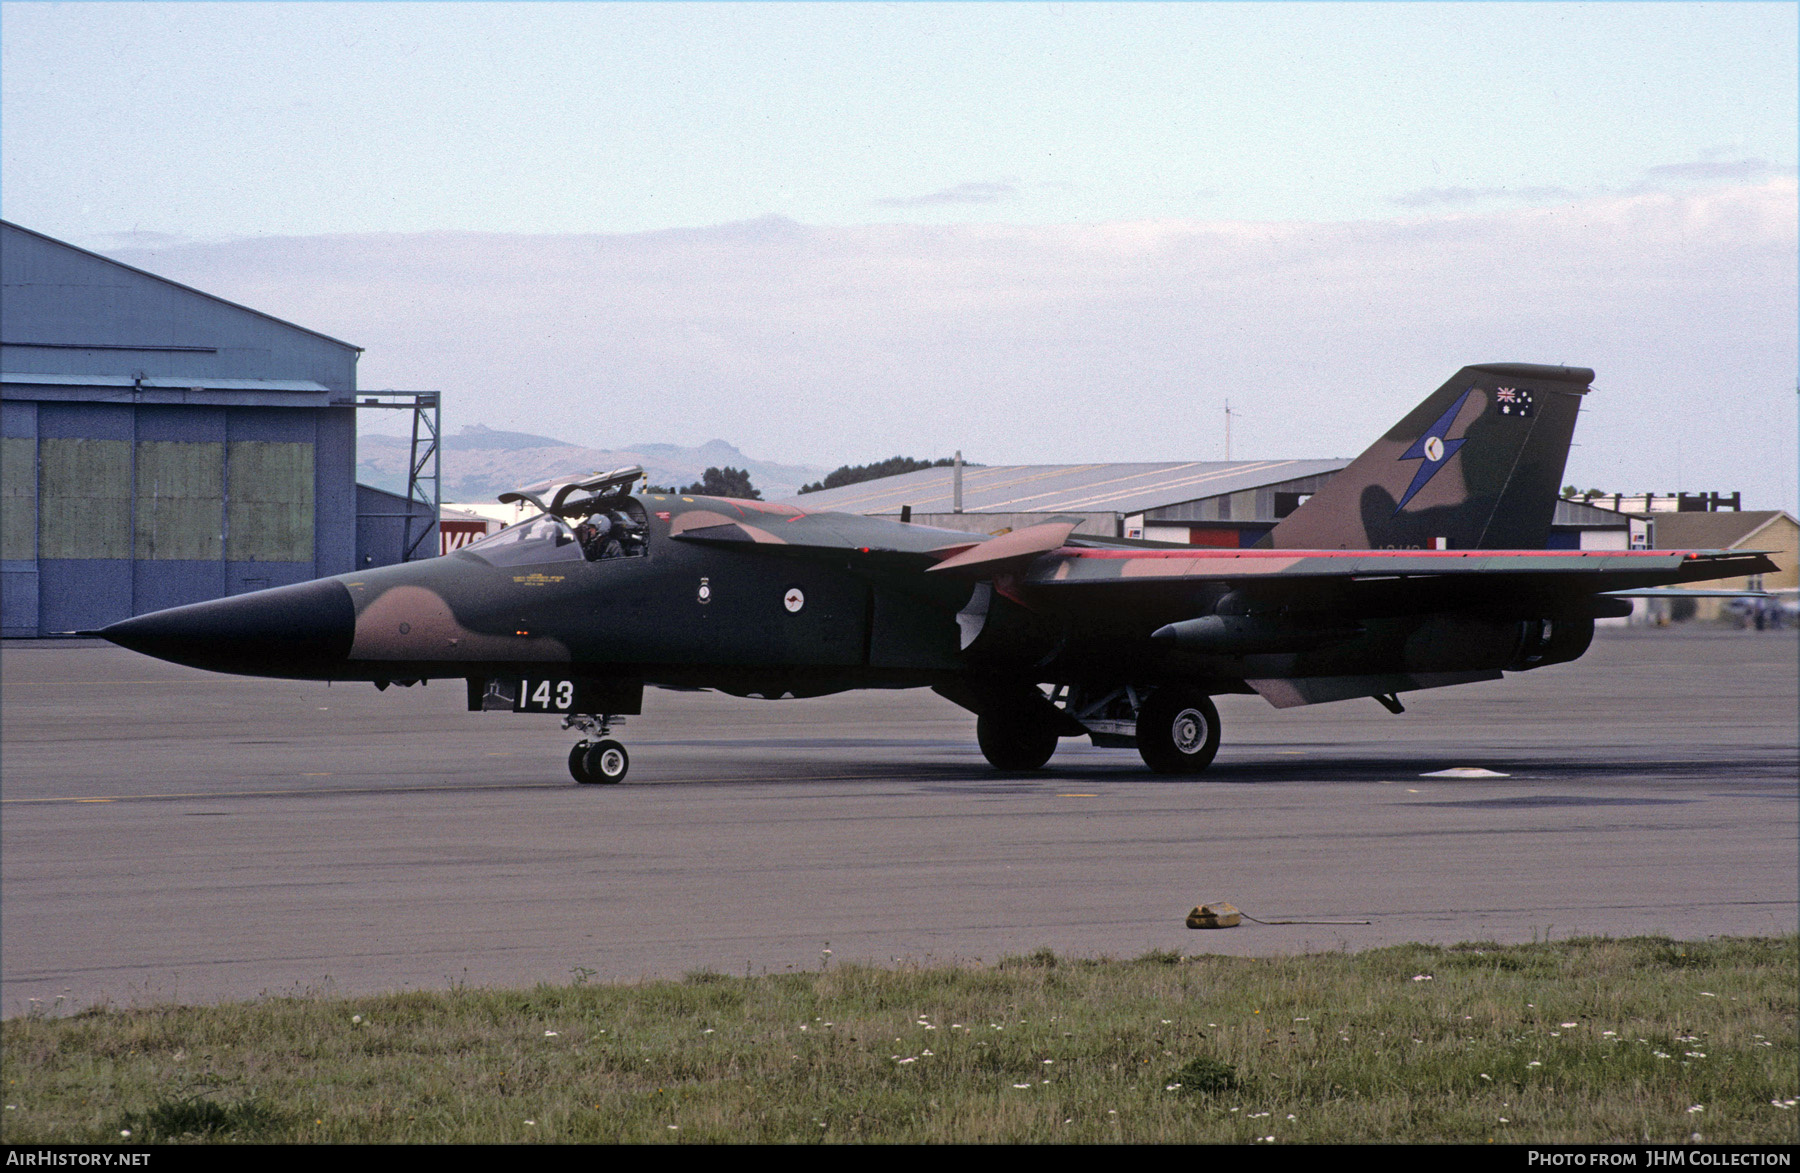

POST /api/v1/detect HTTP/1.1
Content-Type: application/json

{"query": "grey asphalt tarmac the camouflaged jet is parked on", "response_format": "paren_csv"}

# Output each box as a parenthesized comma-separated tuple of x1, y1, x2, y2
(0, 628, 1800, 1015)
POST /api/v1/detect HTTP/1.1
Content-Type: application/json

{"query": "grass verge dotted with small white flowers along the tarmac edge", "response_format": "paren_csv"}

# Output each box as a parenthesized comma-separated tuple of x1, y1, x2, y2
(0, 937, 1800, 1142)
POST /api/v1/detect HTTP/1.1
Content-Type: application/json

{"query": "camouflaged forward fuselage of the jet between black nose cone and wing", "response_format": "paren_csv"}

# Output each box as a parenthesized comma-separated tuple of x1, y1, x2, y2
(338, 495, 968, 696)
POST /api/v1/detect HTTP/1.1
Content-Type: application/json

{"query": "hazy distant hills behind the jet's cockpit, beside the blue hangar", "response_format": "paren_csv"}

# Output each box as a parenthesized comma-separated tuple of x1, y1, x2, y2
(356, 425, 826, 502)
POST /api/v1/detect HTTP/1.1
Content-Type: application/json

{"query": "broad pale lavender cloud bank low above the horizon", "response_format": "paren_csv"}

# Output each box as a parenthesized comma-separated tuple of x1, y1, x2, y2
(102, 178, 1800, 509)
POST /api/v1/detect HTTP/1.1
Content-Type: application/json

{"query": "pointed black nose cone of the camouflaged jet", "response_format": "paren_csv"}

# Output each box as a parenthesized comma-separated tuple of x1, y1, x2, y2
(99, 579, 356, 678)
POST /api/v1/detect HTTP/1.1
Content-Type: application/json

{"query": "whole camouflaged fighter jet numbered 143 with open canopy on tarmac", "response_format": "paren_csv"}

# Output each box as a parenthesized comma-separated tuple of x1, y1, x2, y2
(99, 363, 1775, 783)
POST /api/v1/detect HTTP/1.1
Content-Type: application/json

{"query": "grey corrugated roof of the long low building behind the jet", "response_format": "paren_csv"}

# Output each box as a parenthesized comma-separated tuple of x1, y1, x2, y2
(788, 461, 1350, 513)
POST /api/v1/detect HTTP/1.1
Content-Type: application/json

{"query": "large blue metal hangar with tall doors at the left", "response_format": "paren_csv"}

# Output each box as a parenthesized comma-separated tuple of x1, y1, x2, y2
(0, 223, 437, 637)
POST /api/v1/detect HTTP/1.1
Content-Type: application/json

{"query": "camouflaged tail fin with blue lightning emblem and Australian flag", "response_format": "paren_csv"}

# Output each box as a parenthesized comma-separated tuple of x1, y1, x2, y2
(1267, 363, 1593, 551)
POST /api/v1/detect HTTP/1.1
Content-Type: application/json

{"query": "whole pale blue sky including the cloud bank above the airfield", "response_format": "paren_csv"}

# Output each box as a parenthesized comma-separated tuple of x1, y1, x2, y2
(0, 4, 1800, 509)
